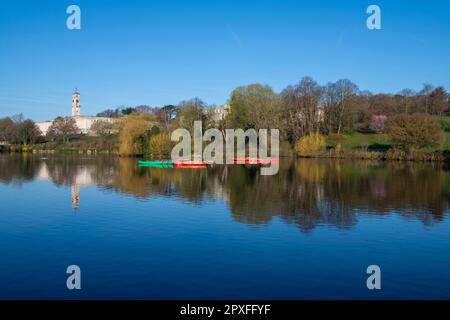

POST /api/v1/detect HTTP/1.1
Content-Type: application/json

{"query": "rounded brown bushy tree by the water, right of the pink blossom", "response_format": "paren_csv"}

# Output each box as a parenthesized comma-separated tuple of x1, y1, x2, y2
(388, 114, 444, 150)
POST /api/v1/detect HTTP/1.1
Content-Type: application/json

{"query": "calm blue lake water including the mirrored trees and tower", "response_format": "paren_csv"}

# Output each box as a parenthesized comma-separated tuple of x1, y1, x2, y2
(0, 155, 450, 299)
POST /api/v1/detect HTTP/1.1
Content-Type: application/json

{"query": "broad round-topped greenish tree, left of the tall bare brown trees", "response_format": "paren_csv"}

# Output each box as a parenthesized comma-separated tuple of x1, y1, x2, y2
(227, 84, 281, 130)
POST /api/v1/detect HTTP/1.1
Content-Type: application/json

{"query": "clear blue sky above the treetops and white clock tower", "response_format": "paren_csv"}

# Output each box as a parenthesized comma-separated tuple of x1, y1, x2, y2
(0, 0, 450, 120)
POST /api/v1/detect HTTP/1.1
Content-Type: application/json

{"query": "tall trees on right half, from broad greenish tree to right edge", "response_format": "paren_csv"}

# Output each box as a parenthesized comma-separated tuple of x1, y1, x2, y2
(224, 77, 450, 142)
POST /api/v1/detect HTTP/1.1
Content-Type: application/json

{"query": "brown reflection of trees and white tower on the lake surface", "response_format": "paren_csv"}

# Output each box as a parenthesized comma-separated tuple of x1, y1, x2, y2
(0, 155, 450, 232)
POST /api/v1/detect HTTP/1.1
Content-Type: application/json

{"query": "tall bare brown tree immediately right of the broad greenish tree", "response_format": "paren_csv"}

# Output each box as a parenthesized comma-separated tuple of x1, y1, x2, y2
(281, 77, 323, 142)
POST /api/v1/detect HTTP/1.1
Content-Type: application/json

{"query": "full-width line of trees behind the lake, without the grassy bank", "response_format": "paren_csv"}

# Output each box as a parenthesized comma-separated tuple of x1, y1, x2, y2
(0, 77, 450, 153)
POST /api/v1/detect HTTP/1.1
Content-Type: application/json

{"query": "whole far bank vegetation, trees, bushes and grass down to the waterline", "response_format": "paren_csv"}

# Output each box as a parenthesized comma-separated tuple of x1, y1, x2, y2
(0, 77, 450, 160)
